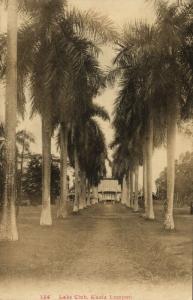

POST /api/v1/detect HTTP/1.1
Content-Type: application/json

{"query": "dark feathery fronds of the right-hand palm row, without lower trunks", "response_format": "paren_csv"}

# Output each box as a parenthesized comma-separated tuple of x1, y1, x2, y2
(108, 1, 193, 188)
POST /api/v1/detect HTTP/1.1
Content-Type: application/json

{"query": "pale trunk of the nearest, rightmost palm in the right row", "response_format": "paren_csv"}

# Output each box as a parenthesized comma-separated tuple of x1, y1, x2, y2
(164, 101, 178, 230)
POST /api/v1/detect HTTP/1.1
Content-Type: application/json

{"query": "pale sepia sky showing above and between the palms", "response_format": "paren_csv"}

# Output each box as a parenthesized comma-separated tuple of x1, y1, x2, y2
(0, 0, 193, 185)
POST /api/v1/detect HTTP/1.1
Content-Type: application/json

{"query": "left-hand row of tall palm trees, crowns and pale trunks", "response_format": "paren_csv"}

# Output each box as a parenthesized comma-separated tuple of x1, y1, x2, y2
(0, 0, 117, 240)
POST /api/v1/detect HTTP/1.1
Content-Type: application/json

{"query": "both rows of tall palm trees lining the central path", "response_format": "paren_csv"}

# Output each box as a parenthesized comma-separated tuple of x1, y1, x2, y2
(0, 0, 193, 240)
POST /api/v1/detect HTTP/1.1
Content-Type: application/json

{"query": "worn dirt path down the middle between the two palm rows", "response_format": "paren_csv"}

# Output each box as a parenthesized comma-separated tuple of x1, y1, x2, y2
(68, 205, 138, 281)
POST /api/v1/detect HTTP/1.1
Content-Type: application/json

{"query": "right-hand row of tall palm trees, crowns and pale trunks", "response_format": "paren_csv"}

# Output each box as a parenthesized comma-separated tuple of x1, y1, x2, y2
(109, 1, 193, 230)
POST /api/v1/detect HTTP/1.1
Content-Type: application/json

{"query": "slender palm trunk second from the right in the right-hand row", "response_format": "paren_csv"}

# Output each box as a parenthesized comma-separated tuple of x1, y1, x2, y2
(146, 107, 155, 220)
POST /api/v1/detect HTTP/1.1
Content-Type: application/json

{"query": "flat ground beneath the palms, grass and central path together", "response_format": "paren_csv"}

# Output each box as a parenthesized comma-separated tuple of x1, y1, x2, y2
(0, 204, 193, 300)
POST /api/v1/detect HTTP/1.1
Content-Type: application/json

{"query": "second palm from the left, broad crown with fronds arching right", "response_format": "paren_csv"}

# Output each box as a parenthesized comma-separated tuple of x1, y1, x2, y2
(0, 0, 116, 224)
